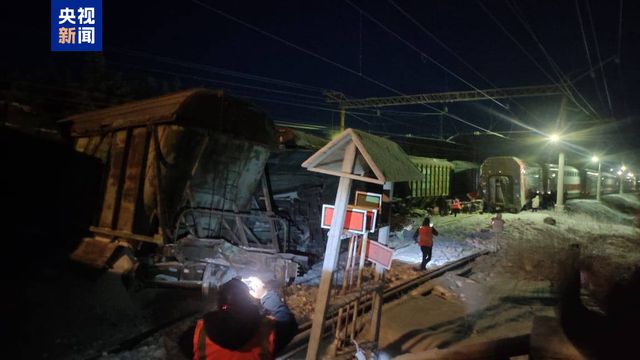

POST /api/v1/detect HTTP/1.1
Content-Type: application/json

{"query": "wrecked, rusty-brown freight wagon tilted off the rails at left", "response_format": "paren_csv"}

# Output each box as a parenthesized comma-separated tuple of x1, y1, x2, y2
(64, 89, 305, 291)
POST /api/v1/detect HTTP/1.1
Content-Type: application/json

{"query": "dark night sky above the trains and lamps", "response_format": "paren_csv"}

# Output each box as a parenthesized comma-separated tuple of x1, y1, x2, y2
(2, 0, 640, 164)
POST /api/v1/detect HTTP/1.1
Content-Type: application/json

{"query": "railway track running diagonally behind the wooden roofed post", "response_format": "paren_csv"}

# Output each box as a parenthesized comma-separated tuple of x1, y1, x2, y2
(276, 251, 489, 360)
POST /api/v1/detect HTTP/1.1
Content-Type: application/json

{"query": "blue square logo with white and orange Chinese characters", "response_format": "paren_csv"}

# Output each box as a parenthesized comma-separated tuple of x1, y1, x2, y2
(51, 0, 102, 51)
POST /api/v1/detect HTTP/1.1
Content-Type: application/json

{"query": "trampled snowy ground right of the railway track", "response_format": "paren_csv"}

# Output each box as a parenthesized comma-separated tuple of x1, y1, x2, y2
(380, 194, 640, 355)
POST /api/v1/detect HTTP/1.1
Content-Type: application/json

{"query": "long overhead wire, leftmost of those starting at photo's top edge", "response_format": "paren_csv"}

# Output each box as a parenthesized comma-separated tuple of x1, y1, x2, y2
(191, 0, 505, 138)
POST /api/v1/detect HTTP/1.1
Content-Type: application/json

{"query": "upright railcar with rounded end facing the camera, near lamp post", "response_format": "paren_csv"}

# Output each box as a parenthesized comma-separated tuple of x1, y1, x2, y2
(480, 156, 543, 212)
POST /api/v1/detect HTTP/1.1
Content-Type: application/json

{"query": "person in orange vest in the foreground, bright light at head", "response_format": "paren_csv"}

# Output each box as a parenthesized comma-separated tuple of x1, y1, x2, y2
(181, 278, 298, 360)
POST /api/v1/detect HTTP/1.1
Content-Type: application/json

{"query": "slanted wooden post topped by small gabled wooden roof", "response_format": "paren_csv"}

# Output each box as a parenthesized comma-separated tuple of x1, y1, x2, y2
(302, 129, 421, 360)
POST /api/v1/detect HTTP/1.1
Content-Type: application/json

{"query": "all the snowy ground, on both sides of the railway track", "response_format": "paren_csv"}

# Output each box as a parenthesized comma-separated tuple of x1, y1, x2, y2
(104, 194, 640, 360)
